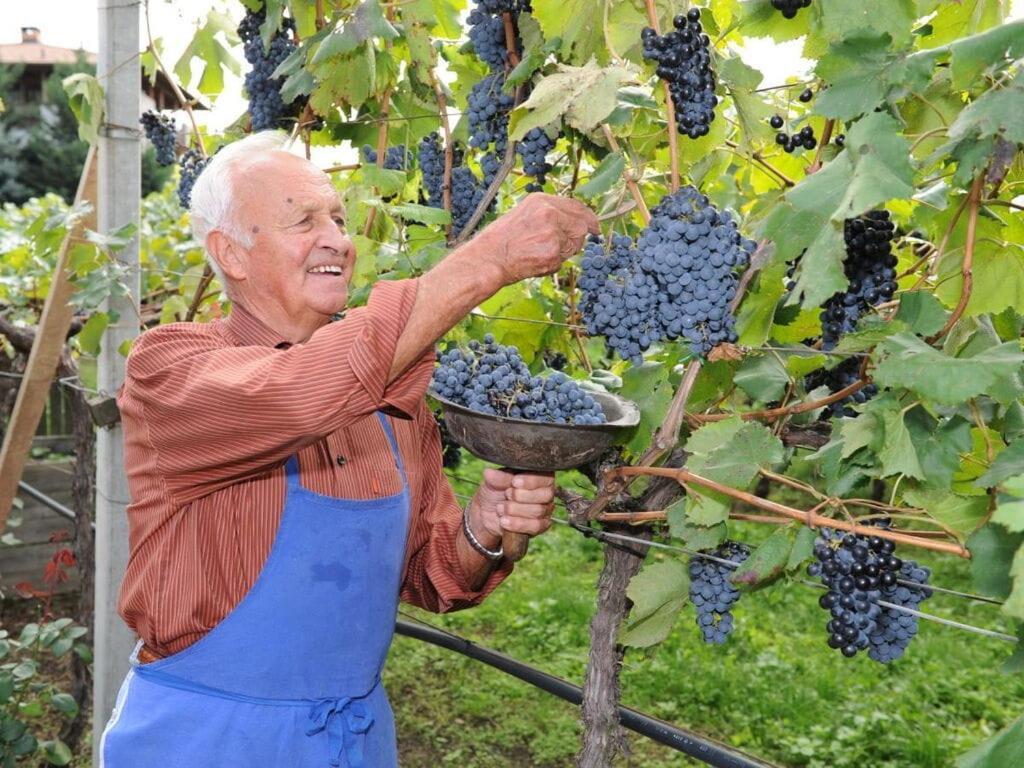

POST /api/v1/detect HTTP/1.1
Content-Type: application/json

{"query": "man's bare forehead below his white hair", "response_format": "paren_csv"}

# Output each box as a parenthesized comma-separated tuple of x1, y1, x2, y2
(231, 152, 344, 215)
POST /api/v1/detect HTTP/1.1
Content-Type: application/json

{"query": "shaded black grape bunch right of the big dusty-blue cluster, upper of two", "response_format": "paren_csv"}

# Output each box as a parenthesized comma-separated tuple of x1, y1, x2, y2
(821, 210, 896, 350)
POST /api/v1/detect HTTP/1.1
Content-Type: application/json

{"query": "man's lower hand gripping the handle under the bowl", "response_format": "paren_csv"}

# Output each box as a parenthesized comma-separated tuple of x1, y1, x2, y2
(469, 468, 555, 548)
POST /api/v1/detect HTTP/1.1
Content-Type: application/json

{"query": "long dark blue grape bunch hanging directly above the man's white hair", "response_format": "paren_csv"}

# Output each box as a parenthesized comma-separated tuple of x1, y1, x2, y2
(239, 8, 300, 131)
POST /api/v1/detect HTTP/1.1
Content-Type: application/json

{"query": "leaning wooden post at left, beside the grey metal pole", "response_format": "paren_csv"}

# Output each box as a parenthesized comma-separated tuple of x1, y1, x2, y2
(0, 145, 97, 532)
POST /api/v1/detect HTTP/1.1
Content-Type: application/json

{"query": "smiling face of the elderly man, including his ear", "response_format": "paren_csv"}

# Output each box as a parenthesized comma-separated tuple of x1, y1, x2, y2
(210, 152, 355, 342)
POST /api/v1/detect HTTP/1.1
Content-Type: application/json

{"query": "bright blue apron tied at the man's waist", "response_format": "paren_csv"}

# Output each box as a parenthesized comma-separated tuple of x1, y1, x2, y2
(99, 414, 410, 768)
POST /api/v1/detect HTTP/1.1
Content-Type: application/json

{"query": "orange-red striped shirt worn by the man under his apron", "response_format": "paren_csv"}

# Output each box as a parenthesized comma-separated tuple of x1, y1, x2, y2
(118, 280, 512, 655)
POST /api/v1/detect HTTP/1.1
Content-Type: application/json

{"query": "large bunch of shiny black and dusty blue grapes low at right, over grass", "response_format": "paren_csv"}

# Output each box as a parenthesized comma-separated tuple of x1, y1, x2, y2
(807, 523, 931, 664)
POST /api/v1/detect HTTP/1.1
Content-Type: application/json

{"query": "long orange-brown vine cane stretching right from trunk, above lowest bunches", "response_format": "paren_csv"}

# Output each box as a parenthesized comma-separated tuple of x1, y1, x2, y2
(604, 467, 971, 559)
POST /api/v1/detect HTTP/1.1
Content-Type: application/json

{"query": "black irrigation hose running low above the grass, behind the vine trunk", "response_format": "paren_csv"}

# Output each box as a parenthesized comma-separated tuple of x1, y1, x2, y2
(395, 618, 774, 768)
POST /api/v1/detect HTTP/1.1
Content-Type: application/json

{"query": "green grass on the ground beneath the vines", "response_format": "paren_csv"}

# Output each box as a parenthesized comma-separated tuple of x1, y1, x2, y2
(385, 466, 1024, 768)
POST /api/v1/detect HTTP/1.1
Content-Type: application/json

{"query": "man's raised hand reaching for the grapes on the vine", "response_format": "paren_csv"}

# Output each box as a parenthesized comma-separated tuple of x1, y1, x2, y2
(472, 193, 601, 285)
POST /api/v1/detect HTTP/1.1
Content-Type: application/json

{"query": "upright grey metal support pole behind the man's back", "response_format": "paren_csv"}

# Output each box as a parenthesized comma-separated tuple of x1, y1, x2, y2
(92, 0, 142, 765)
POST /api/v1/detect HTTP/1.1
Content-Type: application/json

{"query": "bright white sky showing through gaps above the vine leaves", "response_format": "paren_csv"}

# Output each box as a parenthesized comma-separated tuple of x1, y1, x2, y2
(14, 0, 1024, 156)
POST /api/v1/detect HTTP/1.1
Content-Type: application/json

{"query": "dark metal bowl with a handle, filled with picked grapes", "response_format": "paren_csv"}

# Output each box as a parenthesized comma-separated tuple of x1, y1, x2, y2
(429, 390, 640, 472)
